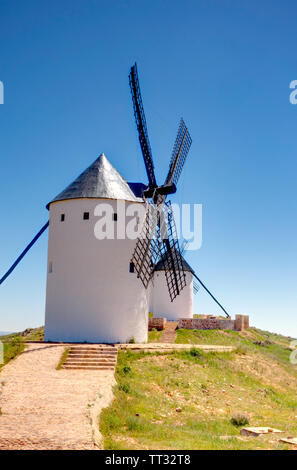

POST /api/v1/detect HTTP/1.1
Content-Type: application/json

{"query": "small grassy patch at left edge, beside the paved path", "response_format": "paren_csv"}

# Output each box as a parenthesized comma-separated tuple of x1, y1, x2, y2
(0, 327, 44, 369)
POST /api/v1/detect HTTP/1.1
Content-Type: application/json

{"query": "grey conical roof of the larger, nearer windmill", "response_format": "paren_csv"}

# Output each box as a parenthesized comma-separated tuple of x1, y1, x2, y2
(47, 153, 142, 208)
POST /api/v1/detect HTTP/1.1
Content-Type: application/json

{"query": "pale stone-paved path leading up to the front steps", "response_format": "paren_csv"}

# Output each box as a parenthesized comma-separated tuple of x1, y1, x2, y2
(0, 344, 114, 450)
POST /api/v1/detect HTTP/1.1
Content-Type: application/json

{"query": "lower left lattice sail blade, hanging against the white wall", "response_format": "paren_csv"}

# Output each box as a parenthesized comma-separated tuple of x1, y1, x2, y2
(131, 203, 162, 289)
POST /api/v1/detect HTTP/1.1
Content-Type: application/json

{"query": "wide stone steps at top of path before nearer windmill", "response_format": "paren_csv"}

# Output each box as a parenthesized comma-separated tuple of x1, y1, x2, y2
(62, 345, 118, 370)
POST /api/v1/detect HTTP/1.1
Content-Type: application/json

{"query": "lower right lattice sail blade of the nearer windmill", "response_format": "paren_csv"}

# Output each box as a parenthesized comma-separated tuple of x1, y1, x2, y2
(160, 202, 186, 302)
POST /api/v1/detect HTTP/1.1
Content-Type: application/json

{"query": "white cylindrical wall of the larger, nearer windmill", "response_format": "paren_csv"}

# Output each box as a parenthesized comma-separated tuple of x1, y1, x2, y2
(45, 198, 149, 343)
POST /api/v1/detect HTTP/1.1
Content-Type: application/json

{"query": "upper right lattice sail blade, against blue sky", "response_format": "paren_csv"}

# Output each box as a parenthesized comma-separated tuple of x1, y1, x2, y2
(166, 119, 192, 185)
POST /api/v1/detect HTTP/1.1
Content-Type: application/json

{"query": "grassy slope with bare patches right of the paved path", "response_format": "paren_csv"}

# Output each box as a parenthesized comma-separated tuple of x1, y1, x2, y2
(100, 328, 297, 450)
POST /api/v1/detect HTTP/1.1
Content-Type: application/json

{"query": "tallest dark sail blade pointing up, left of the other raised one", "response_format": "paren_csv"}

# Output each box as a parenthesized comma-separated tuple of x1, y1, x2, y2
(129, 63, 157, 188)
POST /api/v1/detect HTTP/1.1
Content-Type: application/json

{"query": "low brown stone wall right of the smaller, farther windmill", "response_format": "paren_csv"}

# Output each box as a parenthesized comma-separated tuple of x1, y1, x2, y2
(178, 315, 249, 331)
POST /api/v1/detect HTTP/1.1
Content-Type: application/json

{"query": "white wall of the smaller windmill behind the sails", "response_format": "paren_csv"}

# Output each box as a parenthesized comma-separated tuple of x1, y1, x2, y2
(150, 271, 193, 321)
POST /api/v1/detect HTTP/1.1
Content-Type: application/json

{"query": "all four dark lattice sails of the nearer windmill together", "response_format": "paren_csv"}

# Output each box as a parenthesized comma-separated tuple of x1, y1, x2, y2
(129, 63, 192, 302)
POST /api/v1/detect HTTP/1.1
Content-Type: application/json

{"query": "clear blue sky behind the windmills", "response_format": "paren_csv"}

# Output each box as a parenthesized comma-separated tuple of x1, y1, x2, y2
(0, 0, 297, 337)
